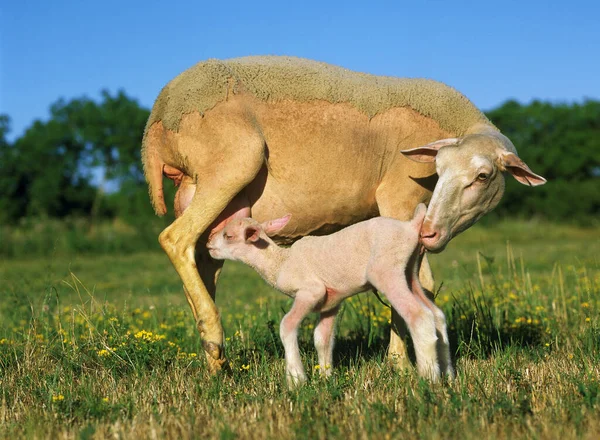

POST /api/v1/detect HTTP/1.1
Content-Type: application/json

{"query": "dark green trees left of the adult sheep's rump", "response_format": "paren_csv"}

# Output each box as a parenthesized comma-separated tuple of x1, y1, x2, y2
(0, 91, 149, 222)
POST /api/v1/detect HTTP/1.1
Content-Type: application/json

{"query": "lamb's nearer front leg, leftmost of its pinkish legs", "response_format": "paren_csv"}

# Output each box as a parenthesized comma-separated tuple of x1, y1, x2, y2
(279, 289, 325, 388)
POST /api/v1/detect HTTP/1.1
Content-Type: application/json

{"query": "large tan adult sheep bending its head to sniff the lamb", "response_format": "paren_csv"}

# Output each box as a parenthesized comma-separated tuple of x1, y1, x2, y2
(142, 57, 545, 371)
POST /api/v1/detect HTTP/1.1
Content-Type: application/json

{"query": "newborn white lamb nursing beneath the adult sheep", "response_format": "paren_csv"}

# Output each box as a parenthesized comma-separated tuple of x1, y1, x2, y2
(207, 204, 454, 387)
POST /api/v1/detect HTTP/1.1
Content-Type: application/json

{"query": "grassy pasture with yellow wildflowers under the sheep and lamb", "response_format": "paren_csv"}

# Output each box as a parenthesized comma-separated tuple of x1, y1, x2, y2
(0, 221, 600, 439)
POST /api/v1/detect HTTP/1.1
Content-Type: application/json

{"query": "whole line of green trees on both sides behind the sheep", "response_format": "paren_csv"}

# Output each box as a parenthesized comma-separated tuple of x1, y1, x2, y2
(0, 91, 600, 225)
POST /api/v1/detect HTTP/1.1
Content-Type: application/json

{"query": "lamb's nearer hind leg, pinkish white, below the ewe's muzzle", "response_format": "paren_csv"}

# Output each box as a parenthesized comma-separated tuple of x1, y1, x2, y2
(371, 270, 440, 382)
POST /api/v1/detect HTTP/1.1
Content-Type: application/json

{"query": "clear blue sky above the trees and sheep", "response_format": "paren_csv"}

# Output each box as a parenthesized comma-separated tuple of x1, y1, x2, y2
(0, 0, 600, 138)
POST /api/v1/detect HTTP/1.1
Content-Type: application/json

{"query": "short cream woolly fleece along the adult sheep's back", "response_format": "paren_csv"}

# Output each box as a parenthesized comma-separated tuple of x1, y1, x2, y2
(146, 56, 491, 136)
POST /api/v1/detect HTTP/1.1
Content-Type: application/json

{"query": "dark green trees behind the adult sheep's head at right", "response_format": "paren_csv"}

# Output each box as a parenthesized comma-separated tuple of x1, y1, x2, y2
(487, 100, 600, 220)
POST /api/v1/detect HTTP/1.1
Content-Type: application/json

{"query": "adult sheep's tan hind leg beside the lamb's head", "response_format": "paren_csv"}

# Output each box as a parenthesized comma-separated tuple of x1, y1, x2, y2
(159, 132, 264, 373)
